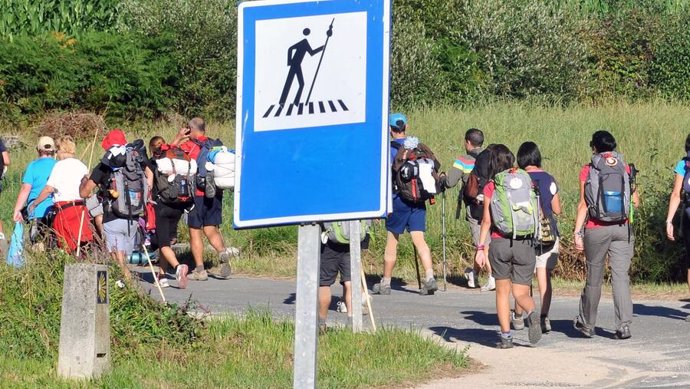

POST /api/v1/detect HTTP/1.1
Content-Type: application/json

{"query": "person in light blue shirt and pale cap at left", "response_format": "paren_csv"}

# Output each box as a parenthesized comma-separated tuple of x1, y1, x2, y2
(13, 136, 56, 243)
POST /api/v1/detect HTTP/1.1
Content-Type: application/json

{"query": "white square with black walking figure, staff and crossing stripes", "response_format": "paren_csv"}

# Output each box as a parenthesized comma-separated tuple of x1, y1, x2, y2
(254, 12, 367, 131)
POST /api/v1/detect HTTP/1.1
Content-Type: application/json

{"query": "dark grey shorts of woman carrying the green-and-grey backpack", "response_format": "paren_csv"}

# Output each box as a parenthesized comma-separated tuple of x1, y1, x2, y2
(489, 238, 536, 285)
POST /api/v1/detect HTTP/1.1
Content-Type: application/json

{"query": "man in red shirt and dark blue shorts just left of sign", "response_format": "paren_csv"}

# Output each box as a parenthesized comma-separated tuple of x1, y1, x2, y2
(171, 117, 239, 281)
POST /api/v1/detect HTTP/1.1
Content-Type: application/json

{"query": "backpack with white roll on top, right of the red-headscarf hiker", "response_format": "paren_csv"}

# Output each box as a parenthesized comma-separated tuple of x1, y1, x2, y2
(155, 147, 197, 204)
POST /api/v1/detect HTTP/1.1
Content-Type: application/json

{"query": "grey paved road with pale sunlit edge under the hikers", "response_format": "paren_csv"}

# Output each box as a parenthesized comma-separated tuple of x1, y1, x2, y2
(136, 270, 690, 389)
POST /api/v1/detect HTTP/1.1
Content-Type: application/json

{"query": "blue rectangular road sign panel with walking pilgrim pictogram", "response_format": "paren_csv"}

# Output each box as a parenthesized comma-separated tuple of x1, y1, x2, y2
(234, 0, 390, 228)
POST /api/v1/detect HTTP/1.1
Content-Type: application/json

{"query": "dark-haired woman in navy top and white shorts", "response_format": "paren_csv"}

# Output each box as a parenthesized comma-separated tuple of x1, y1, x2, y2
(511, 142, 561, 334)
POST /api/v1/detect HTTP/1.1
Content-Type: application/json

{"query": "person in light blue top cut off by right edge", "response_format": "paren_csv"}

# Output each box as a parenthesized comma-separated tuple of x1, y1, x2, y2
(666, 134, 690, 310)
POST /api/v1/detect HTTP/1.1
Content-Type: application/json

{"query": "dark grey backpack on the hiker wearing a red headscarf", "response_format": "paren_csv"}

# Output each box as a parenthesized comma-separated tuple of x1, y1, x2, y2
(104, 144, 149, 219)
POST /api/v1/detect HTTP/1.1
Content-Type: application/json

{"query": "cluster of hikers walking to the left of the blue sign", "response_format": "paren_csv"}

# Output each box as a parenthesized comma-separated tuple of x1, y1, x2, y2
(0, 118, 239, 288)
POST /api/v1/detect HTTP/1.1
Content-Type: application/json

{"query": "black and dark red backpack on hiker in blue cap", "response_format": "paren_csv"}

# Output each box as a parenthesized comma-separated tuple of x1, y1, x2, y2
(391, 137, 441, 203)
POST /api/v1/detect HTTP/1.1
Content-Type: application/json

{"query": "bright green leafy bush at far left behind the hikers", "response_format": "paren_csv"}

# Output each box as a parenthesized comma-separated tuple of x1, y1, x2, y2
(0, 33, 177, 122)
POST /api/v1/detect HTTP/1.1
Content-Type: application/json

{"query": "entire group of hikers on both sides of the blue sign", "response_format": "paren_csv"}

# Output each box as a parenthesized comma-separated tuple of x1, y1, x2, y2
(0, 113, 690, 349)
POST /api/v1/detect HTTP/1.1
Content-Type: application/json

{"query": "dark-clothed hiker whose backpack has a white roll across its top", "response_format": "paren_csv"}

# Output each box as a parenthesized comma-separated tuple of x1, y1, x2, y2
(149, 136, 192, 289)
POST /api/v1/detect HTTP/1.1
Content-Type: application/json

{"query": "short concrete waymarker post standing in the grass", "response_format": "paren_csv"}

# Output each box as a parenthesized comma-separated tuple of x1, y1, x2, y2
(58, 263, 110, 379)
